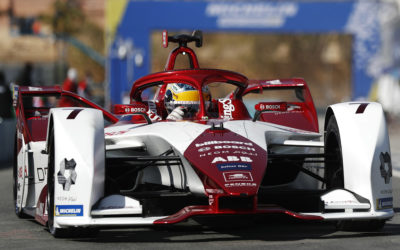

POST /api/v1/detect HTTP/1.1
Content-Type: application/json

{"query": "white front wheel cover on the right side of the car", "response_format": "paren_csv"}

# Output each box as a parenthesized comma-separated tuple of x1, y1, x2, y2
(330, 103, 393, 215)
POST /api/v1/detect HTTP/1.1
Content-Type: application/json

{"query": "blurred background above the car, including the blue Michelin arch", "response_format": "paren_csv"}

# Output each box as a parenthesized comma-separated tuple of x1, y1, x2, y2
(0, 0, 400, 161)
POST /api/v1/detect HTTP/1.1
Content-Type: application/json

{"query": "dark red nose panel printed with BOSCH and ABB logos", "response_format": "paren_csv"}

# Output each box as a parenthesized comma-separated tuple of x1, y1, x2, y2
(184, 129, 267, 196)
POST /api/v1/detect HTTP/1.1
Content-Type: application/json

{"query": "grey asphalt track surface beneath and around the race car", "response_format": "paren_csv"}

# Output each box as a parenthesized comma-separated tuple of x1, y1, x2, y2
(0, 125, 400, 250)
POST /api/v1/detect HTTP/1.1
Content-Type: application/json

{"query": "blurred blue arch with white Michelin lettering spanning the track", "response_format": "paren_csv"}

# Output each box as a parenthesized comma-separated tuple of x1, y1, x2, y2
(107, 0, 390, 104)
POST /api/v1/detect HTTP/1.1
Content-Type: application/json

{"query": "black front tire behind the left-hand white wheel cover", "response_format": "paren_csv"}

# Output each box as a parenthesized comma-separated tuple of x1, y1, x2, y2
(47, 130, 71, 238)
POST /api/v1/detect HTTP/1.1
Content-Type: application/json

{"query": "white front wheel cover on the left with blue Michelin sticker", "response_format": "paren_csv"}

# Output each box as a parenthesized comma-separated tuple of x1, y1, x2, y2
(48, 108, 105, 227)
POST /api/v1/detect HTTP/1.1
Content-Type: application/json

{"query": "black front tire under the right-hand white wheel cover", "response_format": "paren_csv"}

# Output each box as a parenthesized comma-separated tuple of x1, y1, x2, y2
(324, 115, 386, 232)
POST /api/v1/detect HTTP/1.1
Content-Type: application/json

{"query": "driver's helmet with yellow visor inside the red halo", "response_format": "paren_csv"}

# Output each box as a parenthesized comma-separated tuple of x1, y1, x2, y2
(164, 83, 211, 118)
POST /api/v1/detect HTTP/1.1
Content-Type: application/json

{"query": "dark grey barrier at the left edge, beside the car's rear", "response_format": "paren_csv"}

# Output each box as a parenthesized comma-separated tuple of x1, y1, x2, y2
(0, 119, 15, 164)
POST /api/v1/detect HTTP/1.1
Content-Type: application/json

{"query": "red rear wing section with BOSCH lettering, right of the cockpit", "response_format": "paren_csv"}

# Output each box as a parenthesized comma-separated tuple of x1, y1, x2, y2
(243, 78, 319, 132)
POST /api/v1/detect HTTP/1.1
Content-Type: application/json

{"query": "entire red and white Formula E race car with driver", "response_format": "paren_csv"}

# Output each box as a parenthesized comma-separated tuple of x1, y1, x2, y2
(13, 31, 394, 237)
